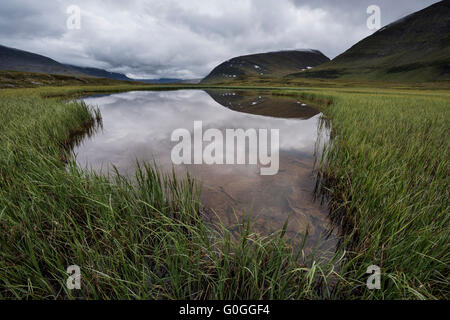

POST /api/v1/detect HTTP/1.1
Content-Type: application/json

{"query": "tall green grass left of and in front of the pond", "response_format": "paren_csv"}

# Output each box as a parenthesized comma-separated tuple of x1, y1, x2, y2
(0, 91, 334, 299)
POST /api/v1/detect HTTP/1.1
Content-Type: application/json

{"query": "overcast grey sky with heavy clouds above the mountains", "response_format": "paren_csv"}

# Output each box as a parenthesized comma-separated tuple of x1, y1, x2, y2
(0, 0, 438, 78)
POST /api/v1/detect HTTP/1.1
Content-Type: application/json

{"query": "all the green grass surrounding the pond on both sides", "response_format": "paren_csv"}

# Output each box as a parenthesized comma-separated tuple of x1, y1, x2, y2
(0, 85, 450, 299)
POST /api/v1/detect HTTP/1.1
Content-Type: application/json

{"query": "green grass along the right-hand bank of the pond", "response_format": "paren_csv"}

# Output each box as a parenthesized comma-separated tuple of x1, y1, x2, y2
(312, 92, 450, 299)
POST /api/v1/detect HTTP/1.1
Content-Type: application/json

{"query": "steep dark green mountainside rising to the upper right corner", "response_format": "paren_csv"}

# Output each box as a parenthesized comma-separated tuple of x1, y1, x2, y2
(290, 0, 450, 81)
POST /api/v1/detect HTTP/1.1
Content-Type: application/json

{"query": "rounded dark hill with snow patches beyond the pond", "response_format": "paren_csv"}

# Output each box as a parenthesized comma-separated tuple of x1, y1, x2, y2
(202, 49, 330, 83)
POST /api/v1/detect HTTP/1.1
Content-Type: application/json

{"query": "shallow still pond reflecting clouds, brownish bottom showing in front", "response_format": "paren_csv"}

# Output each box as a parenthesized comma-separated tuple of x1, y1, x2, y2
(74, 90, 336, 250)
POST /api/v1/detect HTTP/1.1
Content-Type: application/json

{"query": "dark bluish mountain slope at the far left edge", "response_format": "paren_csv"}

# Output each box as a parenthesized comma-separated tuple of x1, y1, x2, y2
(0, 45, 84, 76)
